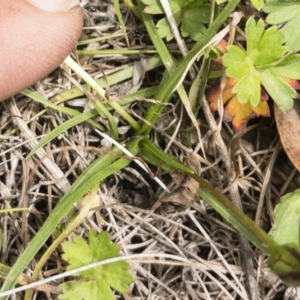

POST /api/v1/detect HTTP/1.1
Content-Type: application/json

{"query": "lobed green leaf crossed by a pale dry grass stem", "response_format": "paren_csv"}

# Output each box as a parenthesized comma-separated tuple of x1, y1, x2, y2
(59, 231, 133, 300)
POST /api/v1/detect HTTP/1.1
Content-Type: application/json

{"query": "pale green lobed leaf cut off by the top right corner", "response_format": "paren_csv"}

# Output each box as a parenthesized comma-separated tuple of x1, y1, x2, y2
(263, 0, 300, 51)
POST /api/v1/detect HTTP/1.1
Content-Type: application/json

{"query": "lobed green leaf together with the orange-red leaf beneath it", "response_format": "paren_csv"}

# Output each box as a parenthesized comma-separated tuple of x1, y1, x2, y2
(208, 18, 300, 130)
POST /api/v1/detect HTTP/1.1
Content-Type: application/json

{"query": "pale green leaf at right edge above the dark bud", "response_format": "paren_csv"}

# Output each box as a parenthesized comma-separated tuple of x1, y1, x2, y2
(269, 189, 300, 245)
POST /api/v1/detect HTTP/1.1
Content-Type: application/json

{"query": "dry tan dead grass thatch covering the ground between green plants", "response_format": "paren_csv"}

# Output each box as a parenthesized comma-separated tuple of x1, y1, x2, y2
(0, 1, 300, 300)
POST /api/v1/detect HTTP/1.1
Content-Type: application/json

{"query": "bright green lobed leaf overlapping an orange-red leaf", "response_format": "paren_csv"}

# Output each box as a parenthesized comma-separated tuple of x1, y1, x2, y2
(223, 18, 300, 111)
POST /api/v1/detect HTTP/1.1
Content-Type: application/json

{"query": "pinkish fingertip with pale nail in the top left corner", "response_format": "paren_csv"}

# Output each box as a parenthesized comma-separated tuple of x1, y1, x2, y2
(0, 0, 83, 102)
